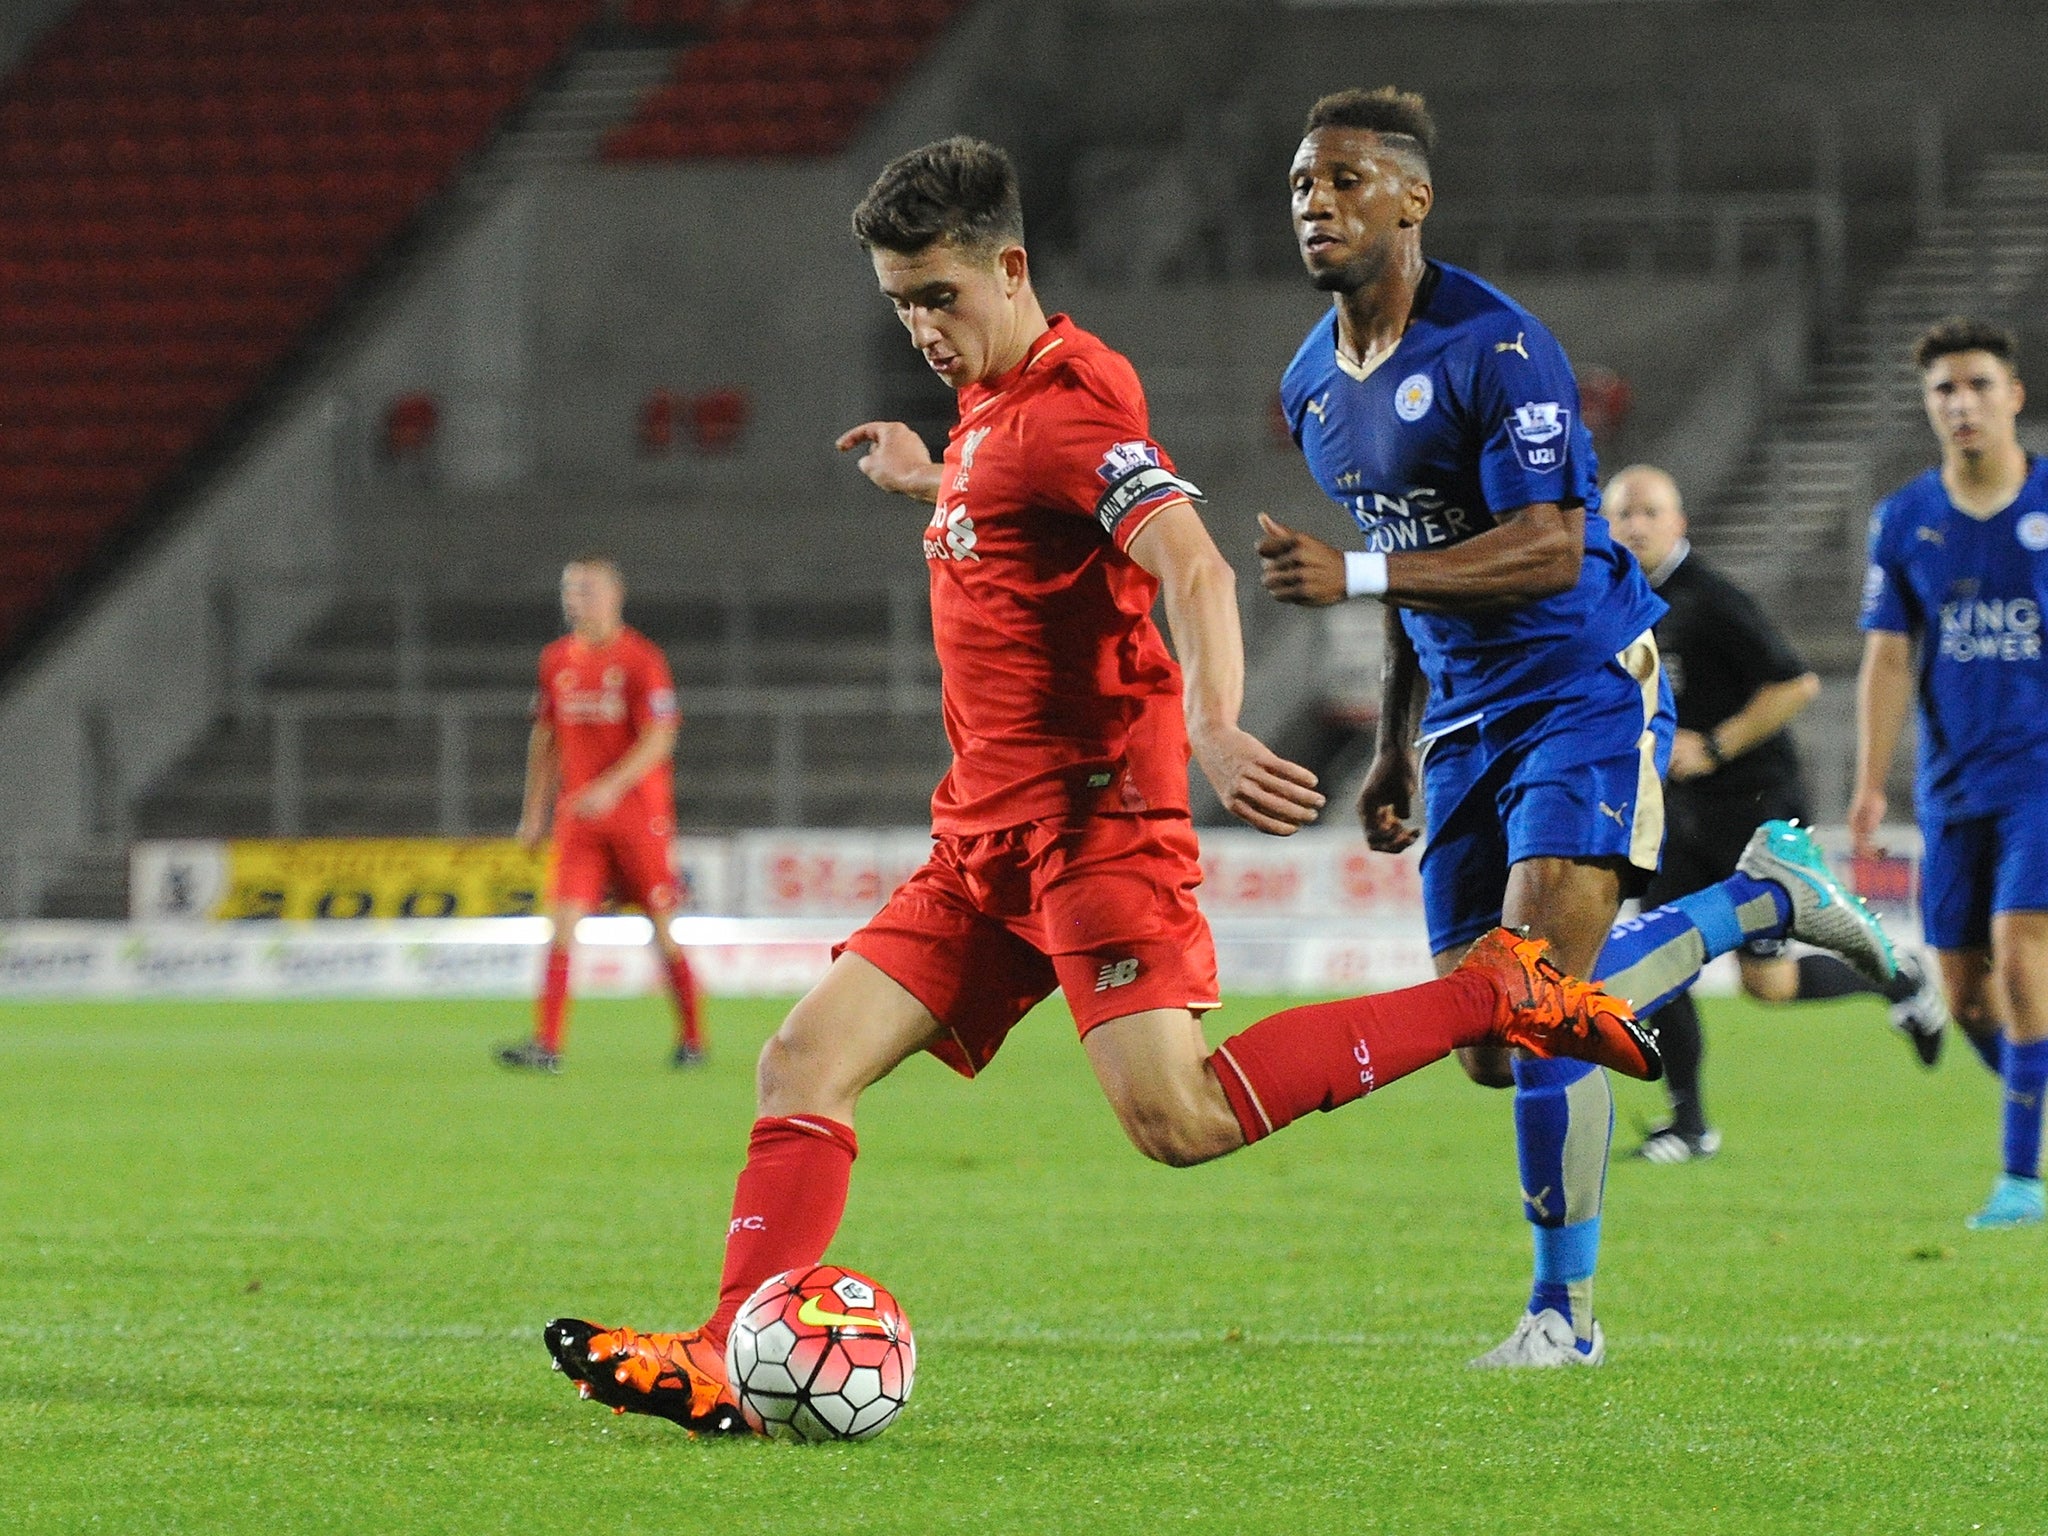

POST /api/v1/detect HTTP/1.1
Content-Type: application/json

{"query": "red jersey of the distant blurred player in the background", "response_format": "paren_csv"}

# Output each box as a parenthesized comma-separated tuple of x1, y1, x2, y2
(532, 629, 680, 827)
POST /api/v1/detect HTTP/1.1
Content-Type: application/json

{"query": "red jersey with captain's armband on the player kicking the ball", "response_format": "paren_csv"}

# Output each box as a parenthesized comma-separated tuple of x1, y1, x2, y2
(924, 315, 1200, 834)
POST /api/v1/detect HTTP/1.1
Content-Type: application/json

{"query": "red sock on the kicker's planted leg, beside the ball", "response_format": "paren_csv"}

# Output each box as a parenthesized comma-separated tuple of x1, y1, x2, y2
(705, 1114, 860, 1348)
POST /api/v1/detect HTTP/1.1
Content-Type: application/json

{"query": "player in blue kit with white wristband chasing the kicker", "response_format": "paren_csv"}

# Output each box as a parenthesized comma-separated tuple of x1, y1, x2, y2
(1260, 88, 1892, 1366)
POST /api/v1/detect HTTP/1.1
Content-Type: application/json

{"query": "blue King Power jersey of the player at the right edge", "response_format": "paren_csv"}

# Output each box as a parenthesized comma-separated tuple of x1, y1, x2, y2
(1864, 459, 2048, 821)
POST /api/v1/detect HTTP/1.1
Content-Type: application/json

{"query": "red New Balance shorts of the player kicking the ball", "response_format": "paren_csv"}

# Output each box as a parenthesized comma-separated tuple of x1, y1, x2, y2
(834, 813, 1219, 1077)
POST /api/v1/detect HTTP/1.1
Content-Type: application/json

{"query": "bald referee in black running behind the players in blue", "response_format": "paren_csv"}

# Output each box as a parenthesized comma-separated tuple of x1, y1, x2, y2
(1602, 465, 1948, 1163)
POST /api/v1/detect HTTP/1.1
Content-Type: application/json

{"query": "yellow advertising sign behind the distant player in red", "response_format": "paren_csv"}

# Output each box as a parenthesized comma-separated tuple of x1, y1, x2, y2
(207, 838, 547, 922)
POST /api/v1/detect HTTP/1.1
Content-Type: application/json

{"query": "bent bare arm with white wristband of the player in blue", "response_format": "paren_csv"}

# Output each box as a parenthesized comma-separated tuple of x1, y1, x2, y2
(1257, 502, 1585, 612)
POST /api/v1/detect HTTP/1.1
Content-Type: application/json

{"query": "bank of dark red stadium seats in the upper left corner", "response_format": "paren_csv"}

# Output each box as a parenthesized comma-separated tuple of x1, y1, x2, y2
(0, 0, 596, 655)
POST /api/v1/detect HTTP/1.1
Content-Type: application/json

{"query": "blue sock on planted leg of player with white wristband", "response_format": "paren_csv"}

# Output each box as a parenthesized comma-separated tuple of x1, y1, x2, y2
(1513, 1059, 1614, 1352)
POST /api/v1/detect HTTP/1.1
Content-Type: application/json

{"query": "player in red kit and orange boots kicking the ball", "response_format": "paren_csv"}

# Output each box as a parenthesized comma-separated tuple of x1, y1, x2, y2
(545, 139, 1657, 1430)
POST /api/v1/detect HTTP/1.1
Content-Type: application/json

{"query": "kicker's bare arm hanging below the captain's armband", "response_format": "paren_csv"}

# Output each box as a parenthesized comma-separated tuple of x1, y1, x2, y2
(1130, 502, 1323, 838)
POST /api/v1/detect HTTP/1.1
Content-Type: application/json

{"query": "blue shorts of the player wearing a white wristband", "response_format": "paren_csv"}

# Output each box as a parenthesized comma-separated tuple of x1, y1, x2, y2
(1421, 633, 1677, 954)
